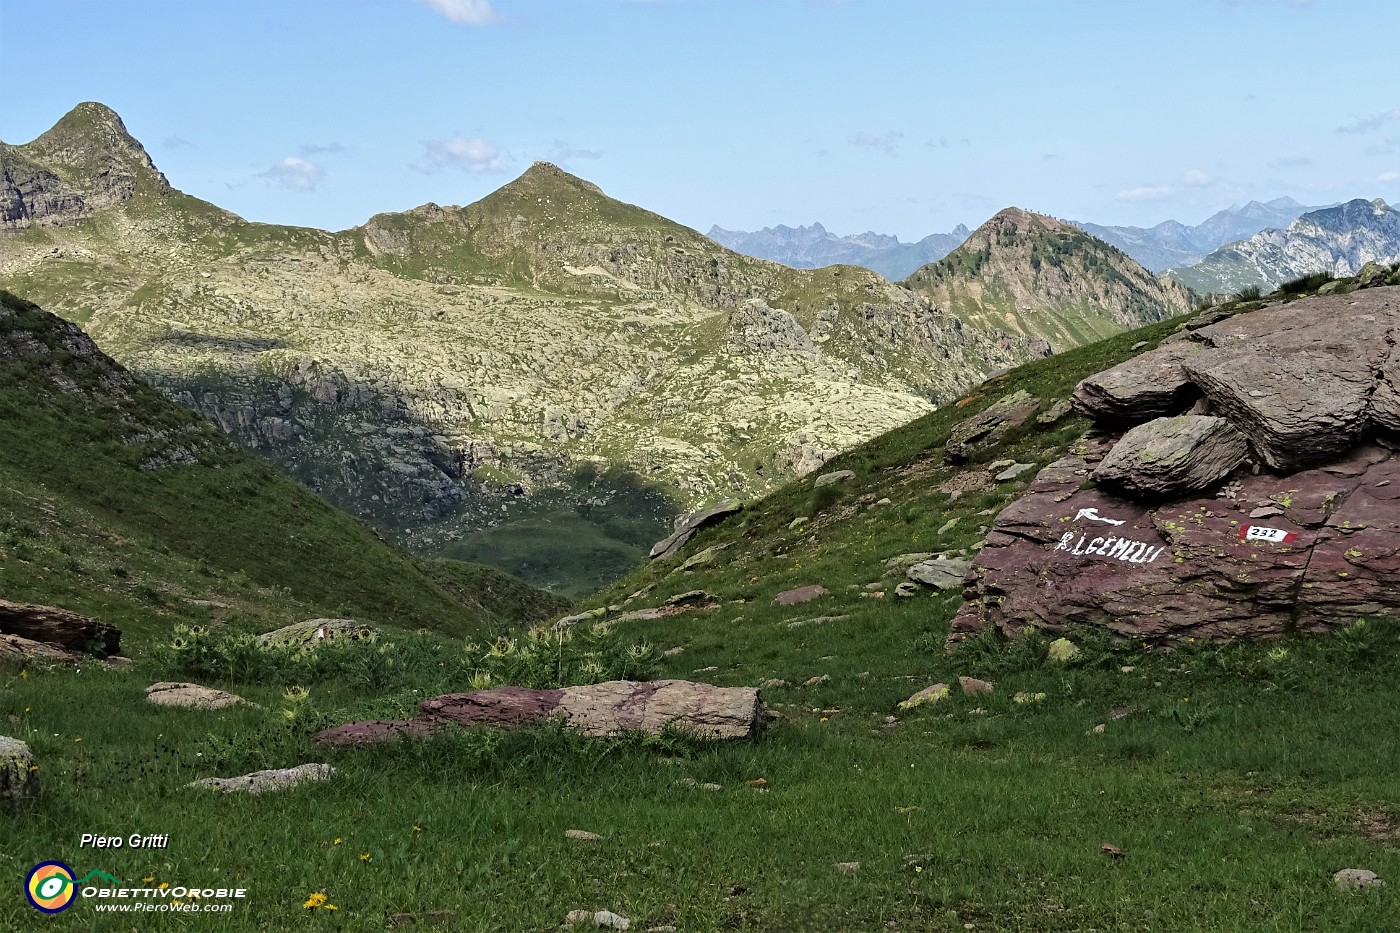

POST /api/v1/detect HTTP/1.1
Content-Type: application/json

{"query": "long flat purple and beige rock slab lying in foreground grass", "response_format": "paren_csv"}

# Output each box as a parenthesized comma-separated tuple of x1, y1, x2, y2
(316, 681, 766, 745)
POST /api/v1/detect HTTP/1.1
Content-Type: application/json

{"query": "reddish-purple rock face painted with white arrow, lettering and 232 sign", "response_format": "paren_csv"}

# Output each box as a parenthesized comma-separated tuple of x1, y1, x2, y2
(951, 437, 1400, 642)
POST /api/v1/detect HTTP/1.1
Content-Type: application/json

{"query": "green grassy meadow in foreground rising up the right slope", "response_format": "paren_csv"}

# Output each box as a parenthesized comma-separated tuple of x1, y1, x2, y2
(0, 273, 1400, 933)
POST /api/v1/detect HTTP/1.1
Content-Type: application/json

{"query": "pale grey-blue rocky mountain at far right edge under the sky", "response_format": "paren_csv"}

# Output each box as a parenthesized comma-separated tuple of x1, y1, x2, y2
(1168, 198, 1400, 294)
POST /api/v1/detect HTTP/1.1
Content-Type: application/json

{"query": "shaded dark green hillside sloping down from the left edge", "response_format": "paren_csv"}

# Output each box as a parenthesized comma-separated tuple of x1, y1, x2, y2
(0, 291, 560, 650)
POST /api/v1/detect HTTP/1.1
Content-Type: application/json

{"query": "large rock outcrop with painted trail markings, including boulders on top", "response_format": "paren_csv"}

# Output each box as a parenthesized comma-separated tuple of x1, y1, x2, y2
(951, 287, 1400, 642)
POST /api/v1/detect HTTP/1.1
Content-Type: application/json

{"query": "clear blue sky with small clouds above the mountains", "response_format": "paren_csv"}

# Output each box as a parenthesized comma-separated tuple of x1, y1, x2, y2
(0, 0, 1400, 240)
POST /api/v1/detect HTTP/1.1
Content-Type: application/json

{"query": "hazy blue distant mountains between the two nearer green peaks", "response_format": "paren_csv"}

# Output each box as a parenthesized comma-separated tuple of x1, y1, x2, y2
(706, 224, 972, 282)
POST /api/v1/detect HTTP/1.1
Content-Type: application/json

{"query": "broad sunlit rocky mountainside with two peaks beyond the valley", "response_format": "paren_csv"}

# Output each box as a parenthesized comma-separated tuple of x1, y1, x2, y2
(0, 104, 1040, 588)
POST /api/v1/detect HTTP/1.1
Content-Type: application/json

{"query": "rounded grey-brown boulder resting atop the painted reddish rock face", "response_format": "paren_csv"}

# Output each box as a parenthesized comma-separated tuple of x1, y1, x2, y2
(1092, 415, 1249, 497)
